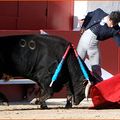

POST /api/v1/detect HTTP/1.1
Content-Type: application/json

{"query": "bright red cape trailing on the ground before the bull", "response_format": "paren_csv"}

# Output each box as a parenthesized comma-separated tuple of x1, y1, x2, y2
(90, 74, 120, 108)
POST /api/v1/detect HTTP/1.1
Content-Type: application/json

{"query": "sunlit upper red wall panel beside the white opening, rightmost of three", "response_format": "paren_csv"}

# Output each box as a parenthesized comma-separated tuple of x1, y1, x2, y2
(47, 0, 73, 30)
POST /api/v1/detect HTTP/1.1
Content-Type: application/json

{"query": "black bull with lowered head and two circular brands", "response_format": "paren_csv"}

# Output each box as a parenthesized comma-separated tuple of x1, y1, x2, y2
(0, 34, 96, 109)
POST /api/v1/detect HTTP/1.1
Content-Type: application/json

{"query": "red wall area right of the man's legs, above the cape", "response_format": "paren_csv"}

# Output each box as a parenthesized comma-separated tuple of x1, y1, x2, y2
(100, 38, 120, 75)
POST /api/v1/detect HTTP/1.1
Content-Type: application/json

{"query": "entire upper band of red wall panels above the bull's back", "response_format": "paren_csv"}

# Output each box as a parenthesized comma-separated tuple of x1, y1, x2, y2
(0, 0, 74, 30)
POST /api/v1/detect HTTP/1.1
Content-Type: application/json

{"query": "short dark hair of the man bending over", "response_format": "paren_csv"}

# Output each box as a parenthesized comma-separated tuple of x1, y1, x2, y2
(109, 11, 120, 25)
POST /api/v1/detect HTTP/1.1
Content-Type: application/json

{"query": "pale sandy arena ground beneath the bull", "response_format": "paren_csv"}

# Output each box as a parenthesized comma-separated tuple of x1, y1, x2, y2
(0, 99, 120, 120)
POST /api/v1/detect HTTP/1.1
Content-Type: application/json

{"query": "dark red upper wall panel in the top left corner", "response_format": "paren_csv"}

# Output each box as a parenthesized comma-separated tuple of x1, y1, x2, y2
(0, 1, 18, 30)
